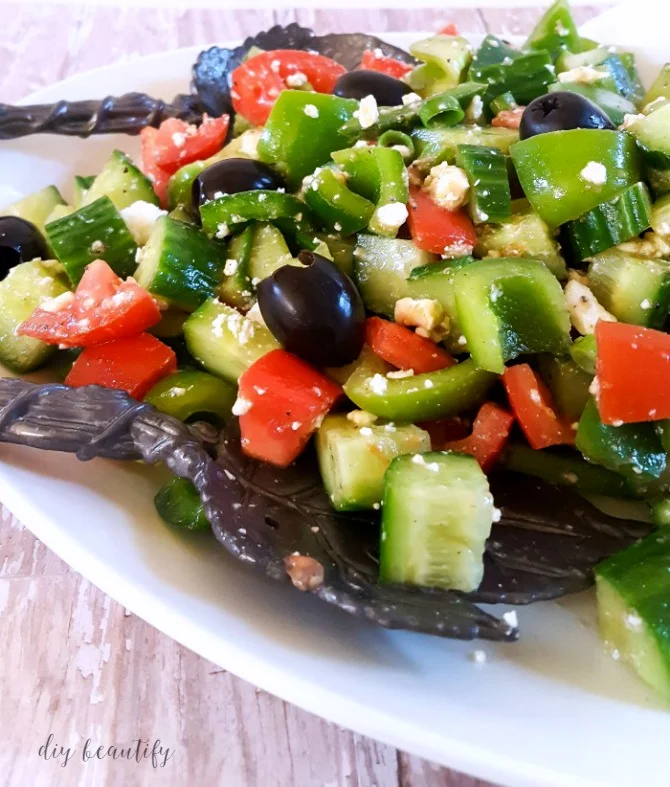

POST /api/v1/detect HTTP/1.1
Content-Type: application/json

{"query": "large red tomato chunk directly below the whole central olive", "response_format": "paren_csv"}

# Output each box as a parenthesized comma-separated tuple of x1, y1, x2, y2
(236, 350, 342, 467)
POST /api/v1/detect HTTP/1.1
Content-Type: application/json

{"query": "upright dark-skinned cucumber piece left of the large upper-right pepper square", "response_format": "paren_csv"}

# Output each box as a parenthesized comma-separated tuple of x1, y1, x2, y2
(456, 145, 512, 224)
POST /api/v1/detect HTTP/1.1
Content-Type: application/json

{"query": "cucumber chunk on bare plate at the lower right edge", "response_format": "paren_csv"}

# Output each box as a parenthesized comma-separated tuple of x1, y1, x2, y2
(595, 530, 670, 699)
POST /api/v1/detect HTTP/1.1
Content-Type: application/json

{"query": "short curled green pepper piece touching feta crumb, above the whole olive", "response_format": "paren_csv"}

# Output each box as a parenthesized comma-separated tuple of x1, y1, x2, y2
(304, 167, 375, 235)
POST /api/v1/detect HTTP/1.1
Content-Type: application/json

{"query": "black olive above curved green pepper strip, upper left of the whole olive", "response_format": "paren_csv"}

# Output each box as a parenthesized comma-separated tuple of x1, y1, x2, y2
(192, 158, 286, 211)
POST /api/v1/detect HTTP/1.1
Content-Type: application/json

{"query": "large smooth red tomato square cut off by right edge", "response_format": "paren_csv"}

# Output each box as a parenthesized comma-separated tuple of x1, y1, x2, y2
(595, 320, 670, 426)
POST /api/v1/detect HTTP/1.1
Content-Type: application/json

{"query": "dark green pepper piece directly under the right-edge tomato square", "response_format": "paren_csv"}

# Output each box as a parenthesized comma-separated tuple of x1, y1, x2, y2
(575, 399, 667, 491)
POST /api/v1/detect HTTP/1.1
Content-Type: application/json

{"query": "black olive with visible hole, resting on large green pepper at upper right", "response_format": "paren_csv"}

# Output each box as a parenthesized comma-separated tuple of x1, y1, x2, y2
(519, 90, 614, 139)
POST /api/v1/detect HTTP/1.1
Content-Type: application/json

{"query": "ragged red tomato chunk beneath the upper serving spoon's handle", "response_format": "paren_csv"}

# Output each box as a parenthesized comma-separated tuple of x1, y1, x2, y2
(140, 115, 230, 205)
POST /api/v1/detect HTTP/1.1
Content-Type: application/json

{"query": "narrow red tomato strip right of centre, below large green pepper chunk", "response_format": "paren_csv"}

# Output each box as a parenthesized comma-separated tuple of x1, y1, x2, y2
(502, 363, 575, 448)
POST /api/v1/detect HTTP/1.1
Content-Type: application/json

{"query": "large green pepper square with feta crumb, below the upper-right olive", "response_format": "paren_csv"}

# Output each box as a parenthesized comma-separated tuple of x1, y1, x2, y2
(510, 128, 641, 228)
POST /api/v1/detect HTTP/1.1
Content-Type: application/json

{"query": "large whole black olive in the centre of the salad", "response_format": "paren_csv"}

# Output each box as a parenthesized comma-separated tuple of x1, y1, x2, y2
(258, 251, 365, 366)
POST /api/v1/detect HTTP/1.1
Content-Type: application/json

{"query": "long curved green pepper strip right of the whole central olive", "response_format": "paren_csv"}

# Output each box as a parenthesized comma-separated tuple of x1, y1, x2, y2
(344, 360, 497, 423)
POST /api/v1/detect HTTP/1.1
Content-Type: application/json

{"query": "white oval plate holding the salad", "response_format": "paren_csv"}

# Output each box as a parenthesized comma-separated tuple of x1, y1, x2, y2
(0, 23, 670, 787)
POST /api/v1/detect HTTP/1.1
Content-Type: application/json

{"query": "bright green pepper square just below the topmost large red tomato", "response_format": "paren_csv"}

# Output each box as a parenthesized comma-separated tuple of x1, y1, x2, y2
(258, 90, 358, 189)
